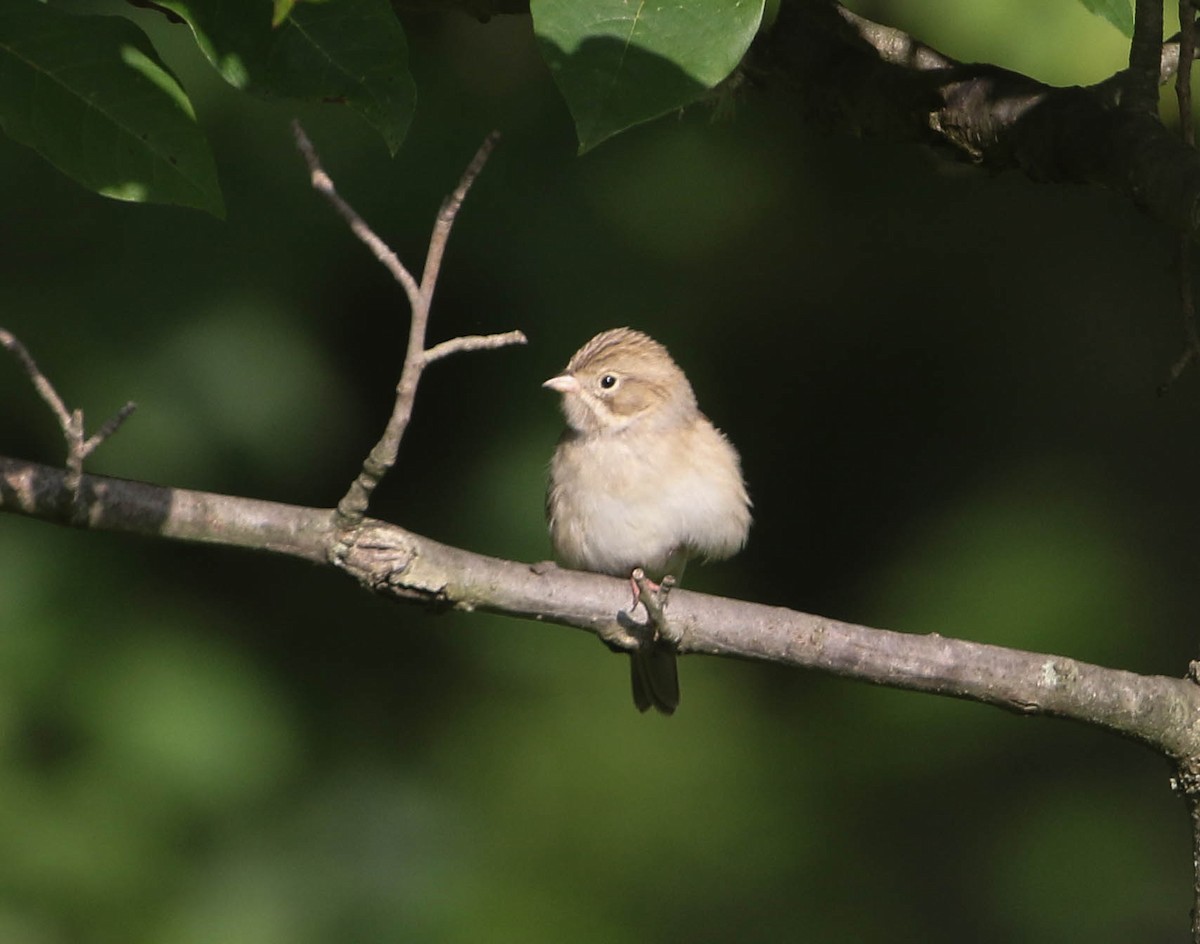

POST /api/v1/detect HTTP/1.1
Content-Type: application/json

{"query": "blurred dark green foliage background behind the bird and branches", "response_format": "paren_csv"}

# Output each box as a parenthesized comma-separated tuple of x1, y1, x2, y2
(0, 2, 1200, 944)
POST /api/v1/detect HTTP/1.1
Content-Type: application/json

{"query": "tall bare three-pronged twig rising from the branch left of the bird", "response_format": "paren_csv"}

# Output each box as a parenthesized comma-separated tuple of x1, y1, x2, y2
(292, 121, 526, 539)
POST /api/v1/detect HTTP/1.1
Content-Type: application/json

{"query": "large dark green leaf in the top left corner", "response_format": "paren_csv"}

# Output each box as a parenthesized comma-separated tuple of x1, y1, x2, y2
(0, 0, 224, 216)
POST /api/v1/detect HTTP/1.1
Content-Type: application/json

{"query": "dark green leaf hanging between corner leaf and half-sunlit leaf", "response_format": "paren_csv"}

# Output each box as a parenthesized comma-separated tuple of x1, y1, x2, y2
(161, 0, 416, 154)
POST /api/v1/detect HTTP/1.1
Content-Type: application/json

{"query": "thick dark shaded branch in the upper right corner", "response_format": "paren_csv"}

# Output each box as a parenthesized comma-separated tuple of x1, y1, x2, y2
(746, 0, 1200, 234)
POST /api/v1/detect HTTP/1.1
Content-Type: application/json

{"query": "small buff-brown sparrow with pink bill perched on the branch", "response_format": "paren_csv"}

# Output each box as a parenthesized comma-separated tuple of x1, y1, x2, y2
(542, 327, 750, 715)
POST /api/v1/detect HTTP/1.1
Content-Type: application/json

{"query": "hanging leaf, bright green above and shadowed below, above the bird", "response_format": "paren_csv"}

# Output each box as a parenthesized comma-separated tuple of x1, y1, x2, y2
(529, 0, 763, 154)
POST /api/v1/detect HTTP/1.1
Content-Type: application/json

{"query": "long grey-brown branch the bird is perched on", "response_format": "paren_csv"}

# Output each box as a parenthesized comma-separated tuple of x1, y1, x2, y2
(7, 458, 1200, 760)
